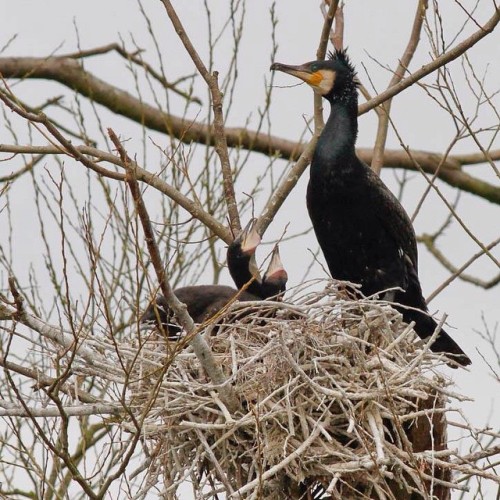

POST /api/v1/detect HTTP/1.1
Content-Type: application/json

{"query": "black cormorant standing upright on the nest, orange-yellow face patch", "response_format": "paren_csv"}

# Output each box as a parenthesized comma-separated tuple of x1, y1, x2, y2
(271, 50, 471, 365)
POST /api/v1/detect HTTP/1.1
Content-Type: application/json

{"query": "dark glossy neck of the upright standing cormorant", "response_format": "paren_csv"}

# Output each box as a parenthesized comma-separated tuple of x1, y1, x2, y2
(312, 93, 358, 170)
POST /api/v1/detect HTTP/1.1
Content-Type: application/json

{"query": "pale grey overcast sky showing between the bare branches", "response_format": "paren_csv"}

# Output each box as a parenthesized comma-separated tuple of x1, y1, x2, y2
(0, 0, 500, 496)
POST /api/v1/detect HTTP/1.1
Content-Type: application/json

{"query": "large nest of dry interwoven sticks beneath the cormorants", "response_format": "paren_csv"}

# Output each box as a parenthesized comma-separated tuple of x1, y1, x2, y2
(130, 286, 464, 499)
